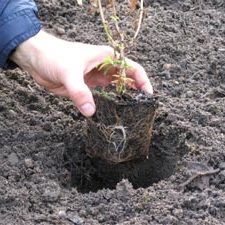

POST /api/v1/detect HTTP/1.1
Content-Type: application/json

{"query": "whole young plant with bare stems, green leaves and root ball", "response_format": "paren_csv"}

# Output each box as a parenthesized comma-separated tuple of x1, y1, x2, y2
(85, 0, 158, 163)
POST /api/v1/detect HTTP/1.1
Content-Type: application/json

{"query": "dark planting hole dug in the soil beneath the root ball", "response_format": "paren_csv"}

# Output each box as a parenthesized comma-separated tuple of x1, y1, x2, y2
(65, 116, 190, 193)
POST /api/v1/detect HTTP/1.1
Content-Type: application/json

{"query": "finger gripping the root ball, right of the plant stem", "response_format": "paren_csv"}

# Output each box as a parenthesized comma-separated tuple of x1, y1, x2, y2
(126, 59, 153, 94)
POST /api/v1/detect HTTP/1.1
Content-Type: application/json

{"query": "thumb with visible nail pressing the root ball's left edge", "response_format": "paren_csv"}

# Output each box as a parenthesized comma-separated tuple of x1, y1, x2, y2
(65, 74, 95, 117)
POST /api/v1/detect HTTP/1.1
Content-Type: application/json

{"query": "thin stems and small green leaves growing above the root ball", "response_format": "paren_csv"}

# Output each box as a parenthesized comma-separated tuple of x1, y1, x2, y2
(98, 0, 144, 95)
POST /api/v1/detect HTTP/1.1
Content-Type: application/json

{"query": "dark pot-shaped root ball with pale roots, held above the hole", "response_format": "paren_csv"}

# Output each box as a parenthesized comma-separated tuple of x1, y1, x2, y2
(85, 89, 158, 163)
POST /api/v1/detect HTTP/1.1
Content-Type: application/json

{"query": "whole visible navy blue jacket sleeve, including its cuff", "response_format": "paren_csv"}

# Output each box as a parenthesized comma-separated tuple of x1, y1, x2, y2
(0, 0, 41, 68)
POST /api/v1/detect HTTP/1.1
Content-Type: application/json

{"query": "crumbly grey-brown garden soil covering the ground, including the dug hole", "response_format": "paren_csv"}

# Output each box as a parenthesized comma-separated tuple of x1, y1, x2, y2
(0, 0, 225, 225)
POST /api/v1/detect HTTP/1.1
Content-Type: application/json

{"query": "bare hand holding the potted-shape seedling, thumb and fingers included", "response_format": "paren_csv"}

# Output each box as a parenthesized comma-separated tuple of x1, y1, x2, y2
(11, 31, 153, 117)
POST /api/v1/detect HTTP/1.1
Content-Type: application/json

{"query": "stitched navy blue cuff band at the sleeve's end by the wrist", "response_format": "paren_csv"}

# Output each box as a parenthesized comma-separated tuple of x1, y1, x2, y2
(0, 9, 41, 69)
